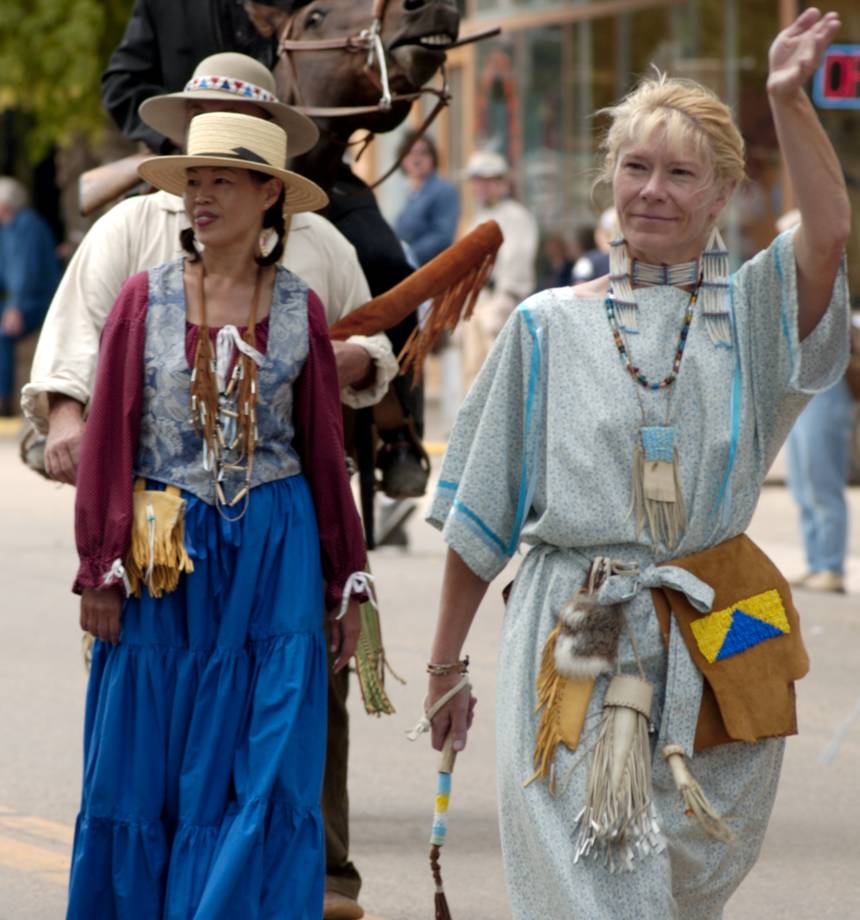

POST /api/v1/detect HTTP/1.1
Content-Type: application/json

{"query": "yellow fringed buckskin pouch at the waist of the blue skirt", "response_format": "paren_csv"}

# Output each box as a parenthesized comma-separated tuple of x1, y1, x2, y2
(125, 479, 194, 597)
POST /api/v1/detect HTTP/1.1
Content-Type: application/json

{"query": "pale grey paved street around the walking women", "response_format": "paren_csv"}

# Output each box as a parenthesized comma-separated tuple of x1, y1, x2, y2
(0, 426, 860, 920)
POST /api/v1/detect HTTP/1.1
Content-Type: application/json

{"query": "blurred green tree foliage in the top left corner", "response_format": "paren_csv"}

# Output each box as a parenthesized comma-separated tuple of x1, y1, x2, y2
(0, 0, 132, 158)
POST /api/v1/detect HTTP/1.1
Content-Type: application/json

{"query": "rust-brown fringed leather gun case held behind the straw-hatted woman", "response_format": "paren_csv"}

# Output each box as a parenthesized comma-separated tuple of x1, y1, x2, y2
(329, 220, 504, 378)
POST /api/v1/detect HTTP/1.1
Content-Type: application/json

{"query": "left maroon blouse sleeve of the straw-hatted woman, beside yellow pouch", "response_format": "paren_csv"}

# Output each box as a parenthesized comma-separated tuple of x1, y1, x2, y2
(72, 272, 149, 594)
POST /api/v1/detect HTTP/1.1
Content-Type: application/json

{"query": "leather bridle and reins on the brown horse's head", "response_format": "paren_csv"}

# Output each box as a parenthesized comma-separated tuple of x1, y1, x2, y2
(278, 0, 500, 188)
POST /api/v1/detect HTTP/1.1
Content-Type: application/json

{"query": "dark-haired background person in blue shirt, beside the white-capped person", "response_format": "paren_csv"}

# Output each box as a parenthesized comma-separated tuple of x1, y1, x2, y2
(394, 131, 460, 266)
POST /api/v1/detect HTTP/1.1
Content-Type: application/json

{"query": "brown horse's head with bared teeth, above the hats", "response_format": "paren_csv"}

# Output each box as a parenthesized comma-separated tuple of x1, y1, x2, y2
(274, 0, 460, 138)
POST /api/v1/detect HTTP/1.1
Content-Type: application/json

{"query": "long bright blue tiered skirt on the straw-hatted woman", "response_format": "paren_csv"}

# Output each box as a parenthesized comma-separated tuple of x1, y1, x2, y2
(68, 476, 327, 920)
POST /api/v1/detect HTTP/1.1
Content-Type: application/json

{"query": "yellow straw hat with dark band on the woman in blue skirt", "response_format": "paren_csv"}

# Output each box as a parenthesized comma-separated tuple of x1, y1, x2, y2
(137, 112, 328, 213)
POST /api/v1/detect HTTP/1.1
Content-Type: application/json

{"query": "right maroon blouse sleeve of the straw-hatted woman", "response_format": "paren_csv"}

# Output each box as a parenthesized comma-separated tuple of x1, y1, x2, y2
(294, 291, 367, 610)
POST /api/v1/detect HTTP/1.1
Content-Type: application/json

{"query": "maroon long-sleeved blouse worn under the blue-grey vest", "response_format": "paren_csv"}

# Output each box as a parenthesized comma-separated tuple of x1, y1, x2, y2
(73, 272, 367, 610)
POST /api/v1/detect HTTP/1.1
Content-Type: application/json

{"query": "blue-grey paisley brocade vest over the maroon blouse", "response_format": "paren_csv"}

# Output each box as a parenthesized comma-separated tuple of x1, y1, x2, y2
(134, 259, 308, 505)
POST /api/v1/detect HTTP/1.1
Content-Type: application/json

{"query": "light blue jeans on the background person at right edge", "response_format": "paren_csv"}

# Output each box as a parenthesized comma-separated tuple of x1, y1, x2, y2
(788, 379, 854, 575)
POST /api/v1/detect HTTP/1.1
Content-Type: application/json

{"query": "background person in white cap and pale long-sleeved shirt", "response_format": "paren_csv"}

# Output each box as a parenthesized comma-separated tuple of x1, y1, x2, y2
(462, 150, 538, 386)
